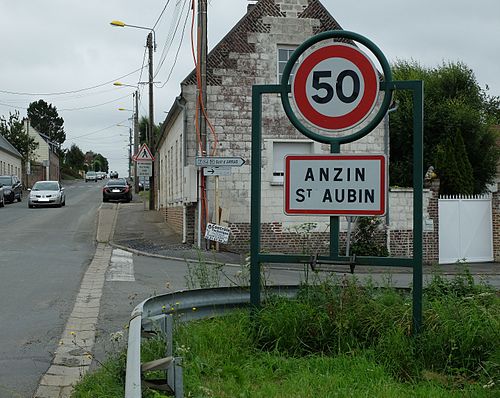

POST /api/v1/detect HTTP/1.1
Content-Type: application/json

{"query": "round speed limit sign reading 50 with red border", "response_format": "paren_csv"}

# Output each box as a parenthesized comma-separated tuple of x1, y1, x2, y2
(292, 44, 379, 131)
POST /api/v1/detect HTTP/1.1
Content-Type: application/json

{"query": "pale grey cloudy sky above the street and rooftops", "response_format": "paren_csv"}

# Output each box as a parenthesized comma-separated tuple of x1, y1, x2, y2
(0, 0, 500, 175)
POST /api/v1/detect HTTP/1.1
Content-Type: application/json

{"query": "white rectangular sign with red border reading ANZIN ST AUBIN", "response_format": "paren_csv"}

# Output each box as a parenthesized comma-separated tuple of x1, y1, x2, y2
(284, 155, 387, 216)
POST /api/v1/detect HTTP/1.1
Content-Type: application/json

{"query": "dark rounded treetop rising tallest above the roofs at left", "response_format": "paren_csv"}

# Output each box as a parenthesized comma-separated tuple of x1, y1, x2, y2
(28, 99, 66, 145)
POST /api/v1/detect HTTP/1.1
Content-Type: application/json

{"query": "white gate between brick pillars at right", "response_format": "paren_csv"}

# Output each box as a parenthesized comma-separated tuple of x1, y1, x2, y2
(439, 195, 493, 264)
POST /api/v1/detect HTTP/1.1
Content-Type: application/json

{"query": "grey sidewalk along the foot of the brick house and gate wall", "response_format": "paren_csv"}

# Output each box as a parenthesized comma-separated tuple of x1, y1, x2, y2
(112, 201, 500, 275)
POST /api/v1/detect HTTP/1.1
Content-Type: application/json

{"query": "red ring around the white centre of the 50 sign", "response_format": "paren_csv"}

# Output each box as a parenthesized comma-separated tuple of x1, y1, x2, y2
(292, 44, 378, 131)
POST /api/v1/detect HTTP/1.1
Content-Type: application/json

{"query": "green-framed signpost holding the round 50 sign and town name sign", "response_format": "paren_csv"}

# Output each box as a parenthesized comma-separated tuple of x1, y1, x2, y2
(250, 30, 423, 335)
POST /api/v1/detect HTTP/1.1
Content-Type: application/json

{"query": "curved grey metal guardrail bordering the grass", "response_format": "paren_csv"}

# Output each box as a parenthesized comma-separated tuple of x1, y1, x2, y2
(125, 285, 299, 398)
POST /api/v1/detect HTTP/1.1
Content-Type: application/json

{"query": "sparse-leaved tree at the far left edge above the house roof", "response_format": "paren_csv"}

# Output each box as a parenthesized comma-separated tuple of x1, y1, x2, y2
(0, 111, 38, 162)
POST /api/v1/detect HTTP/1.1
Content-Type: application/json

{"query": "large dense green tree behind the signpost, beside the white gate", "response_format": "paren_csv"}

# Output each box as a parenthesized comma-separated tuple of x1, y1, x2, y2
(390, 61, 500, 194)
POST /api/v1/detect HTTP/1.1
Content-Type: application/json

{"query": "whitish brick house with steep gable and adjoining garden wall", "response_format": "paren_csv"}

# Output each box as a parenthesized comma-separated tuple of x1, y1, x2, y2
(155, 0, 438, 261)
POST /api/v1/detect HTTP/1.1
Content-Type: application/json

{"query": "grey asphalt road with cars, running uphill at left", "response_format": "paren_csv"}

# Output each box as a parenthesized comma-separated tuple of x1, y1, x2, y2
(0, 182, 104, 398)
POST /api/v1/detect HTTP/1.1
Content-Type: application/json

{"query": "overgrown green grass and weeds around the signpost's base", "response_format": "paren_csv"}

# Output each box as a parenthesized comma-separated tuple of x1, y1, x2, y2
(75, 272, 500, 398)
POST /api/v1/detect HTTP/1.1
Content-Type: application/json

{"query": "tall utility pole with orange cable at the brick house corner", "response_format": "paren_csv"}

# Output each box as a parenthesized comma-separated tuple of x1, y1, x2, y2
(198, 0, 209, 248)
